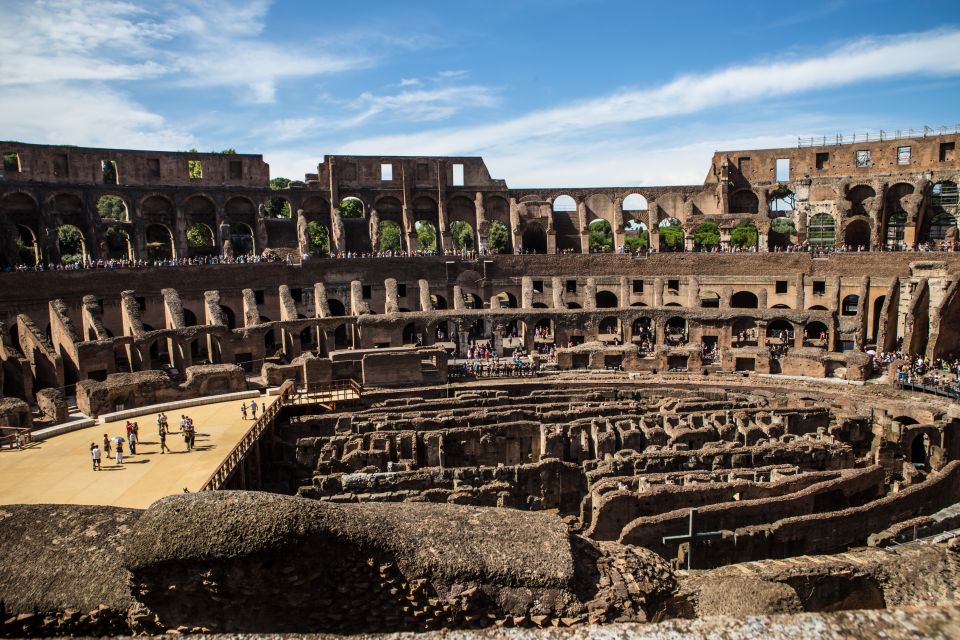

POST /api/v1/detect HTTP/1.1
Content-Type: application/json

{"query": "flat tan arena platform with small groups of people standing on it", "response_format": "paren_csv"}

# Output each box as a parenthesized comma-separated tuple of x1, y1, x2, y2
(0, 398, 266, 508)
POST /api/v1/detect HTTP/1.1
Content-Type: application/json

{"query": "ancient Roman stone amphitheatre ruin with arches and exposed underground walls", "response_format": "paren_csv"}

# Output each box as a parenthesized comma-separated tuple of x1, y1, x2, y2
(0, 133, 960, 638)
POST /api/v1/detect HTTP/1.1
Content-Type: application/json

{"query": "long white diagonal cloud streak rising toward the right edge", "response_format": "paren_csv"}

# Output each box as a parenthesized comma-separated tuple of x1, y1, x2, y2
(342, 31, 960, 155)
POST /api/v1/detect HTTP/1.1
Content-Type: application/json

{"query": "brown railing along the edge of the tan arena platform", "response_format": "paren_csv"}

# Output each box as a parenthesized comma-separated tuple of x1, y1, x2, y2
(200, 380, 362, 491)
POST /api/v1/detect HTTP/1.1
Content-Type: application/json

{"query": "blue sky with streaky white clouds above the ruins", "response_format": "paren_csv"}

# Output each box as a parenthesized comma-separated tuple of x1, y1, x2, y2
(0, 0, 960, 187)
